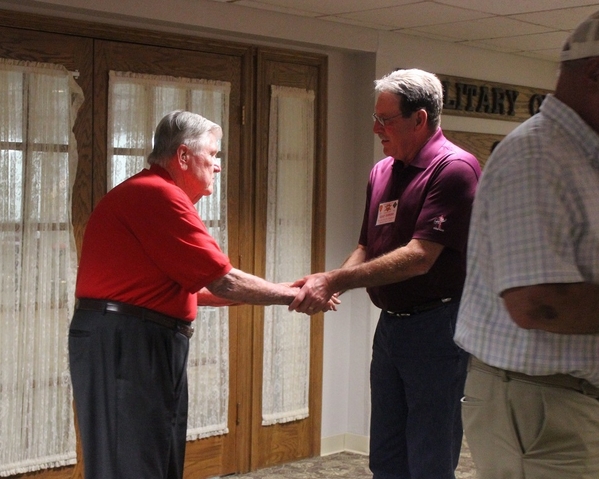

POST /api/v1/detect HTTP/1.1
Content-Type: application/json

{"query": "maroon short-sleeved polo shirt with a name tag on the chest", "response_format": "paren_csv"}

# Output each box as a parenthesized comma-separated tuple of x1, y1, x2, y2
(360, 129, 481, 311)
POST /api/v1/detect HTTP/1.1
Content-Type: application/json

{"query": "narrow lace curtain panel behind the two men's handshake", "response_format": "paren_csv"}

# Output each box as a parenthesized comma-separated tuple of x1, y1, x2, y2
(262, 86, 314, 426)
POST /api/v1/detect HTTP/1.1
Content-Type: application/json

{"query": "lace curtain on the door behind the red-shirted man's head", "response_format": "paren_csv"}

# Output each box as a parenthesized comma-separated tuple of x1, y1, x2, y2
(108, 72, 230, 440)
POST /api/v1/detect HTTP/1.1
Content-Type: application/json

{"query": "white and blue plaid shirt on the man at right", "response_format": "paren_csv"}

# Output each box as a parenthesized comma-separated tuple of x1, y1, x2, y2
(455, 95, 599, 386)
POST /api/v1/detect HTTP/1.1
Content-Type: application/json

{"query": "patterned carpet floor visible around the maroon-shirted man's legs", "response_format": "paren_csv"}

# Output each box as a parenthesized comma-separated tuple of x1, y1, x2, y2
(229, 442, 476, 479)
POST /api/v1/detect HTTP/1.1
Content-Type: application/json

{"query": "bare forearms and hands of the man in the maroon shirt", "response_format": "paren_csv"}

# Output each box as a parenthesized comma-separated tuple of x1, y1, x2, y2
(289, 239, 444, 313)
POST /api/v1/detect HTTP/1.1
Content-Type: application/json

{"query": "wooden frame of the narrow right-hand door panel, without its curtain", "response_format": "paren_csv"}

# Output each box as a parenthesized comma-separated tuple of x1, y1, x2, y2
(251, 49, 327, 469)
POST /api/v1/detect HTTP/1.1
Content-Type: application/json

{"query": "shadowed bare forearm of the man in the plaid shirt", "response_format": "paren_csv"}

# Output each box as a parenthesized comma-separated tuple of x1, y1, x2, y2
(501, 283, 599, 334)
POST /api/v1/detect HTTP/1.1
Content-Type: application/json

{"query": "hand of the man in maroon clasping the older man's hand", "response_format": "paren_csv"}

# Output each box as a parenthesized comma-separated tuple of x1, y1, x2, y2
(289, 273, 341, 314)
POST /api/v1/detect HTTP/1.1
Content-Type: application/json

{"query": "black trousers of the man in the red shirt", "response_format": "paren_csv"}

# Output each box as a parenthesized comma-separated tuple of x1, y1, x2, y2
(69, 311, 189, 479)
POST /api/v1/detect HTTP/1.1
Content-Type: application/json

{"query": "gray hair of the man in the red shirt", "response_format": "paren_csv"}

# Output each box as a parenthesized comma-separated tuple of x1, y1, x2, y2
(148, 110, 223, 167)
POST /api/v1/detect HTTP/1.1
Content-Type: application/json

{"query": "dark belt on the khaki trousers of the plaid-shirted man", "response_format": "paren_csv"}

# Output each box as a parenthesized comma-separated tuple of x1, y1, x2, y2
(468, 356, 599, 399)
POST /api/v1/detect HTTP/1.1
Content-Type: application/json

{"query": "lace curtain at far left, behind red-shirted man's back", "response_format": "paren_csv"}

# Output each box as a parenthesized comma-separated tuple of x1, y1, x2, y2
(0, 59, 83, 476)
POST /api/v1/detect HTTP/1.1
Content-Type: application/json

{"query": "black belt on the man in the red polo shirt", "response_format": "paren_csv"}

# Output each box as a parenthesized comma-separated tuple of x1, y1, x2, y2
(75, 298, 193, 338)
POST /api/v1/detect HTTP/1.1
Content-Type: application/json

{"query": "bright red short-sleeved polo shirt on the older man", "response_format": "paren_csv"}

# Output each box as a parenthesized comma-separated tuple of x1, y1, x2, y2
(75, 165, 232, 321)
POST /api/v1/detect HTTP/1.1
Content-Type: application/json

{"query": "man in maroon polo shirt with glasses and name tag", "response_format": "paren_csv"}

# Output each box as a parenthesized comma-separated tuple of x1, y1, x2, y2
(290, 70, 480, 479)
